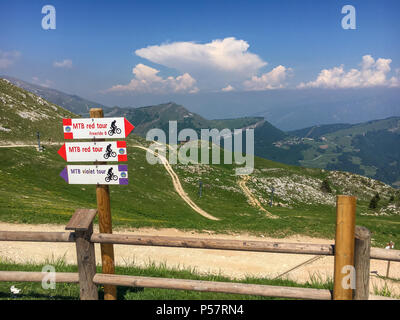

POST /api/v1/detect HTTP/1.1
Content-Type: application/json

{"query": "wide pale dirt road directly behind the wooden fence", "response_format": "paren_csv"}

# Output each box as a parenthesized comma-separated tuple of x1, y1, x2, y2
(0, 222, 400, 295)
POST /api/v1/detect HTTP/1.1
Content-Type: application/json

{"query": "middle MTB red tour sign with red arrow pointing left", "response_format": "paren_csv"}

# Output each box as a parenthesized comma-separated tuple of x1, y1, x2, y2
(58, 141, 128, 162)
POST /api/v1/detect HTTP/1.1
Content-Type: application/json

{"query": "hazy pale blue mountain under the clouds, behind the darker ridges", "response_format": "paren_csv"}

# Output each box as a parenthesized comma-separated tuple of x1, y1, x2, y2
(171, 88, 400, 131)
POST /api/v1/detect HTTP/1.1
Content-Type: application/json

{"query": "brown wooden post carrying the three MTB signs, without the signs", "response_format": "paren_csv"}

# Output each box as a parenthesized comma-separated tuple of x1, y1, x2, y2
(90, 108, 117, 300)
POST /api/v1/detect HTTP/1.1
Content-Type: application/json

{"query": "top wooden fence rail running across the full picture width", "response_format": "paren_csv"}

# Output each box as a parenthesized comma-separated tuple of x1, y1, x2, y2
(0, 231, 400, 262)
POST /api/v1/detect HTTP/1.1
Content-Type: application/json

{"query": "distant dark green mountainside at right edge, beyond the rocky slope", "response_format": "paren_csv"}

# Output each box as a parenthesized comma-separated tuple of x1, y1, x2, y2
(275, 117, 400, 186)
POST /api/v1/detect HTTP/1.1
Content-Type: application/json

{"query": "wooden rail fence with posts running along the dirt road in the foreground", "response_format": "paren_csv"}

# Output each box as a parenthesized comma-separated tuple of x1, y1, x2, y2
(0, 196, 400, 300)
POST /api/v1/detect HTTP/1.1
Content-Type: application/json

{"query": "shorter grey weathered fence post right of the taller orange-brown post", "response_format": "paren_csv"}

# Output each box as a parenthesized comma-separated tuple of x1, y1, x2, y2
(354, 226, 371, 300)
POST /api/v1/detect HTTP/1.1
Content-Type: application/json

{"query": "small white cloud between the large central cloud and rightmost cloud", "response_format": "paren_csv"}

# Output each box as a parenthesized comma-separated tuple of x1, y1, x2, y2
(243, 65, 292, 91)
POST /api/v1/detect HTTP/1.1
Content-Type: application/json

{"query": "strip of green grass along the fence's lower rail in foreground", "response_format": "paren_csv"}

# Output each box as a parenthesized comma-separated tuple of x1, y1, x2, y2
(0, 260, 333, 300)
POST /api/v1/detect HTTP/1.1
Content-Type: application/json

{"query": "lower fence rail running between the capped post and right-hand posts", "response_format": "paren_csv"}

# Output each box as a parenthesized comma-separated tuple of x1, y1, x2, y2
(93, 273, 332, 300)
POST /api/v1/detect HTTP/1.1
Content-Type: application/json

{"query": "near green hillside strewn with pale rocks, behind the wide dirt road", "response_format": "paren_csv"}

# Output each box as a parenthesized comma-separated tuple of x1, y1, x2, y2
(0, 80, 400, 245)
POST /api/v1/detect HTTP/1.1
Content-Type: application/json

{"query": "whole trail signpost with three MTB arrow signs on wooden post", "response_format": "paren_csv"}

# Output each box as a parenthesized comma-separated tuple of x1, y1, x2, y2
(58, 108, 134, 300)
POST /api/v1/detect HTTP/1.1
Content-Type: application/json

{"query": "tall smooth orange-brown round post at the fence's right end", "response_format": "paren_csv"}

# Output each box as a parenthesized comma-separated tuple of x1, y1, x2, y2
(333, 195, 357, 300)
